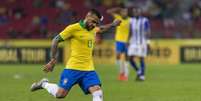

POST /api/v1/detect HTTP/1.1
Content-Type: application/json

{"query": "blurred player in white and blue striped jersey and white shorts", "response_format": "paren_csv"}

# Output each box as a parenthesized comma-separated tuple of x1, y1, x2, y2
(128, 8, 151, 81)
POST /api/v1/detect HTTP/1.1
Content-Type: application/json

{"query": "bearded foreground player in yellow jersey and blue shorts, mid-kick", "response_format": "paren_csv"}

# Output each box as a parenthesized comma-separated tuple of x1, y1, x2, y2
(31, 9, 120, 101)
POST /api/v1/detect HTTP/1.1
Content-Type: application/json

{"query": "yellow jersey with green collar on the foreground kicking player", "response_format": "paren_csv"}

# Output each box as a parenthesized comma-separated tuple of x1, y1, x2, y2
(60, 20, 96, 71)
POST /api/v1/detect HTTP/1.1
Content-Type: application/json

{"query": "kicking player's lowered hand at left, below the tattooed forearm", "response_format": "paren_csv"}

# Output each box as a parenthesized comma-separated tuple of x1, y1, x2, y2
(43, 59, 56, 73)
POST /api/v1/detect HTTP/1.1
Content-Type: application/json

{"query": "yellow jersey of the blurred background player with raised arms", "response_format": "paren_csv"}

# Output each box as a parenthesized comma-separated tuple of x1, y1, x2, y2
(113, 14, 130, 43)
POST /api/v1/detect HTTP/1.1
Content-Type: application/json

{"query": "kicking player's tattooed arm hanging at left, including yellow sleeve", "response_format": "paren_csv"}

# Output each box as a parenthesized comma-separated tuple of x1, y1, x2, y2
(43, 26, 73, 73)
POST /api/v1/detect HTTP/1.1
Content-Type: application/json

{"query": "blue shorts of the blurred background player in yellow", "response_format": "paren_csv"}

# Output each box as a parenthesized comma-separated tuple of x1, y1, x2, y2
(116, 41, 128, 53)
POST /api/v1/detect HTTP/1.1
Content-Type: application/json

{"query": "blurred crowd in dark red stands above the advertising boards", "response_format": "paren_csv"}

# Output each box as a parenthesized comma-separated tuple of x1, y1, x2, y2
(0, 0, 201, 39)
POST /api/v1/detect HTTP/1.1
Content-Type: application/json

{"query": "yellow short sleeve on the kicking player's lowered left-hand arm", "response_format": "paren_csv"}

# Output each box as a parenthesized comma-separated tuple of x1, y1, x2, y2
(59, 25, 74, 40)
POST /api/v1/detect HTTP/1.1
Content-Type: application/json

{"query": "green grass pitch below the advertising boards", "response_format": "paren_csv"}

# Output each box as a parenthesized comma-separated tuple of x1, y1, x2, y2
(0, 64, 201, 101)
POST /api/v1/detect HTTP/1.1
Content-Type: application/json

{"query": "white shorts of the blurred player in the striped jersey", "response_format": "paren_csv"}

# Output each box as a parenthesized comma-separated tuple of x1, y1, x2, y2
(128, 44, 147, 57)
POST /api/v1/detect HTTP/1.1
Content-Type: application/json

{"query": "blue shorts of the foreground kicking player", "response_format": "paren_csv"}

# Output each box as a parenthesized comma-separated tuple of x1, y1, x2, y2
(59, 69, 101, 94)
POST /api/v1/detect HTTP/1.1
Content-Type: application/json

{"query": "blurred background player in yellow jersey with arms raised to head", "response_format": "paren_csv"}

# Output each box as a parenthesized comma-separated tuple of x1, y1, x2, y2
(107, 7, 130, 81)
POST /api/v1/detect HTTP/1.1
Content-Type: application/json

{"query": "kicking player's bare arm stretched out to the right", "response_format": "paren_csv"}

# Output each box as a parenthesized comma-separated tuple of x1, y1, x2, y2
(96, 20, 121, 33)
